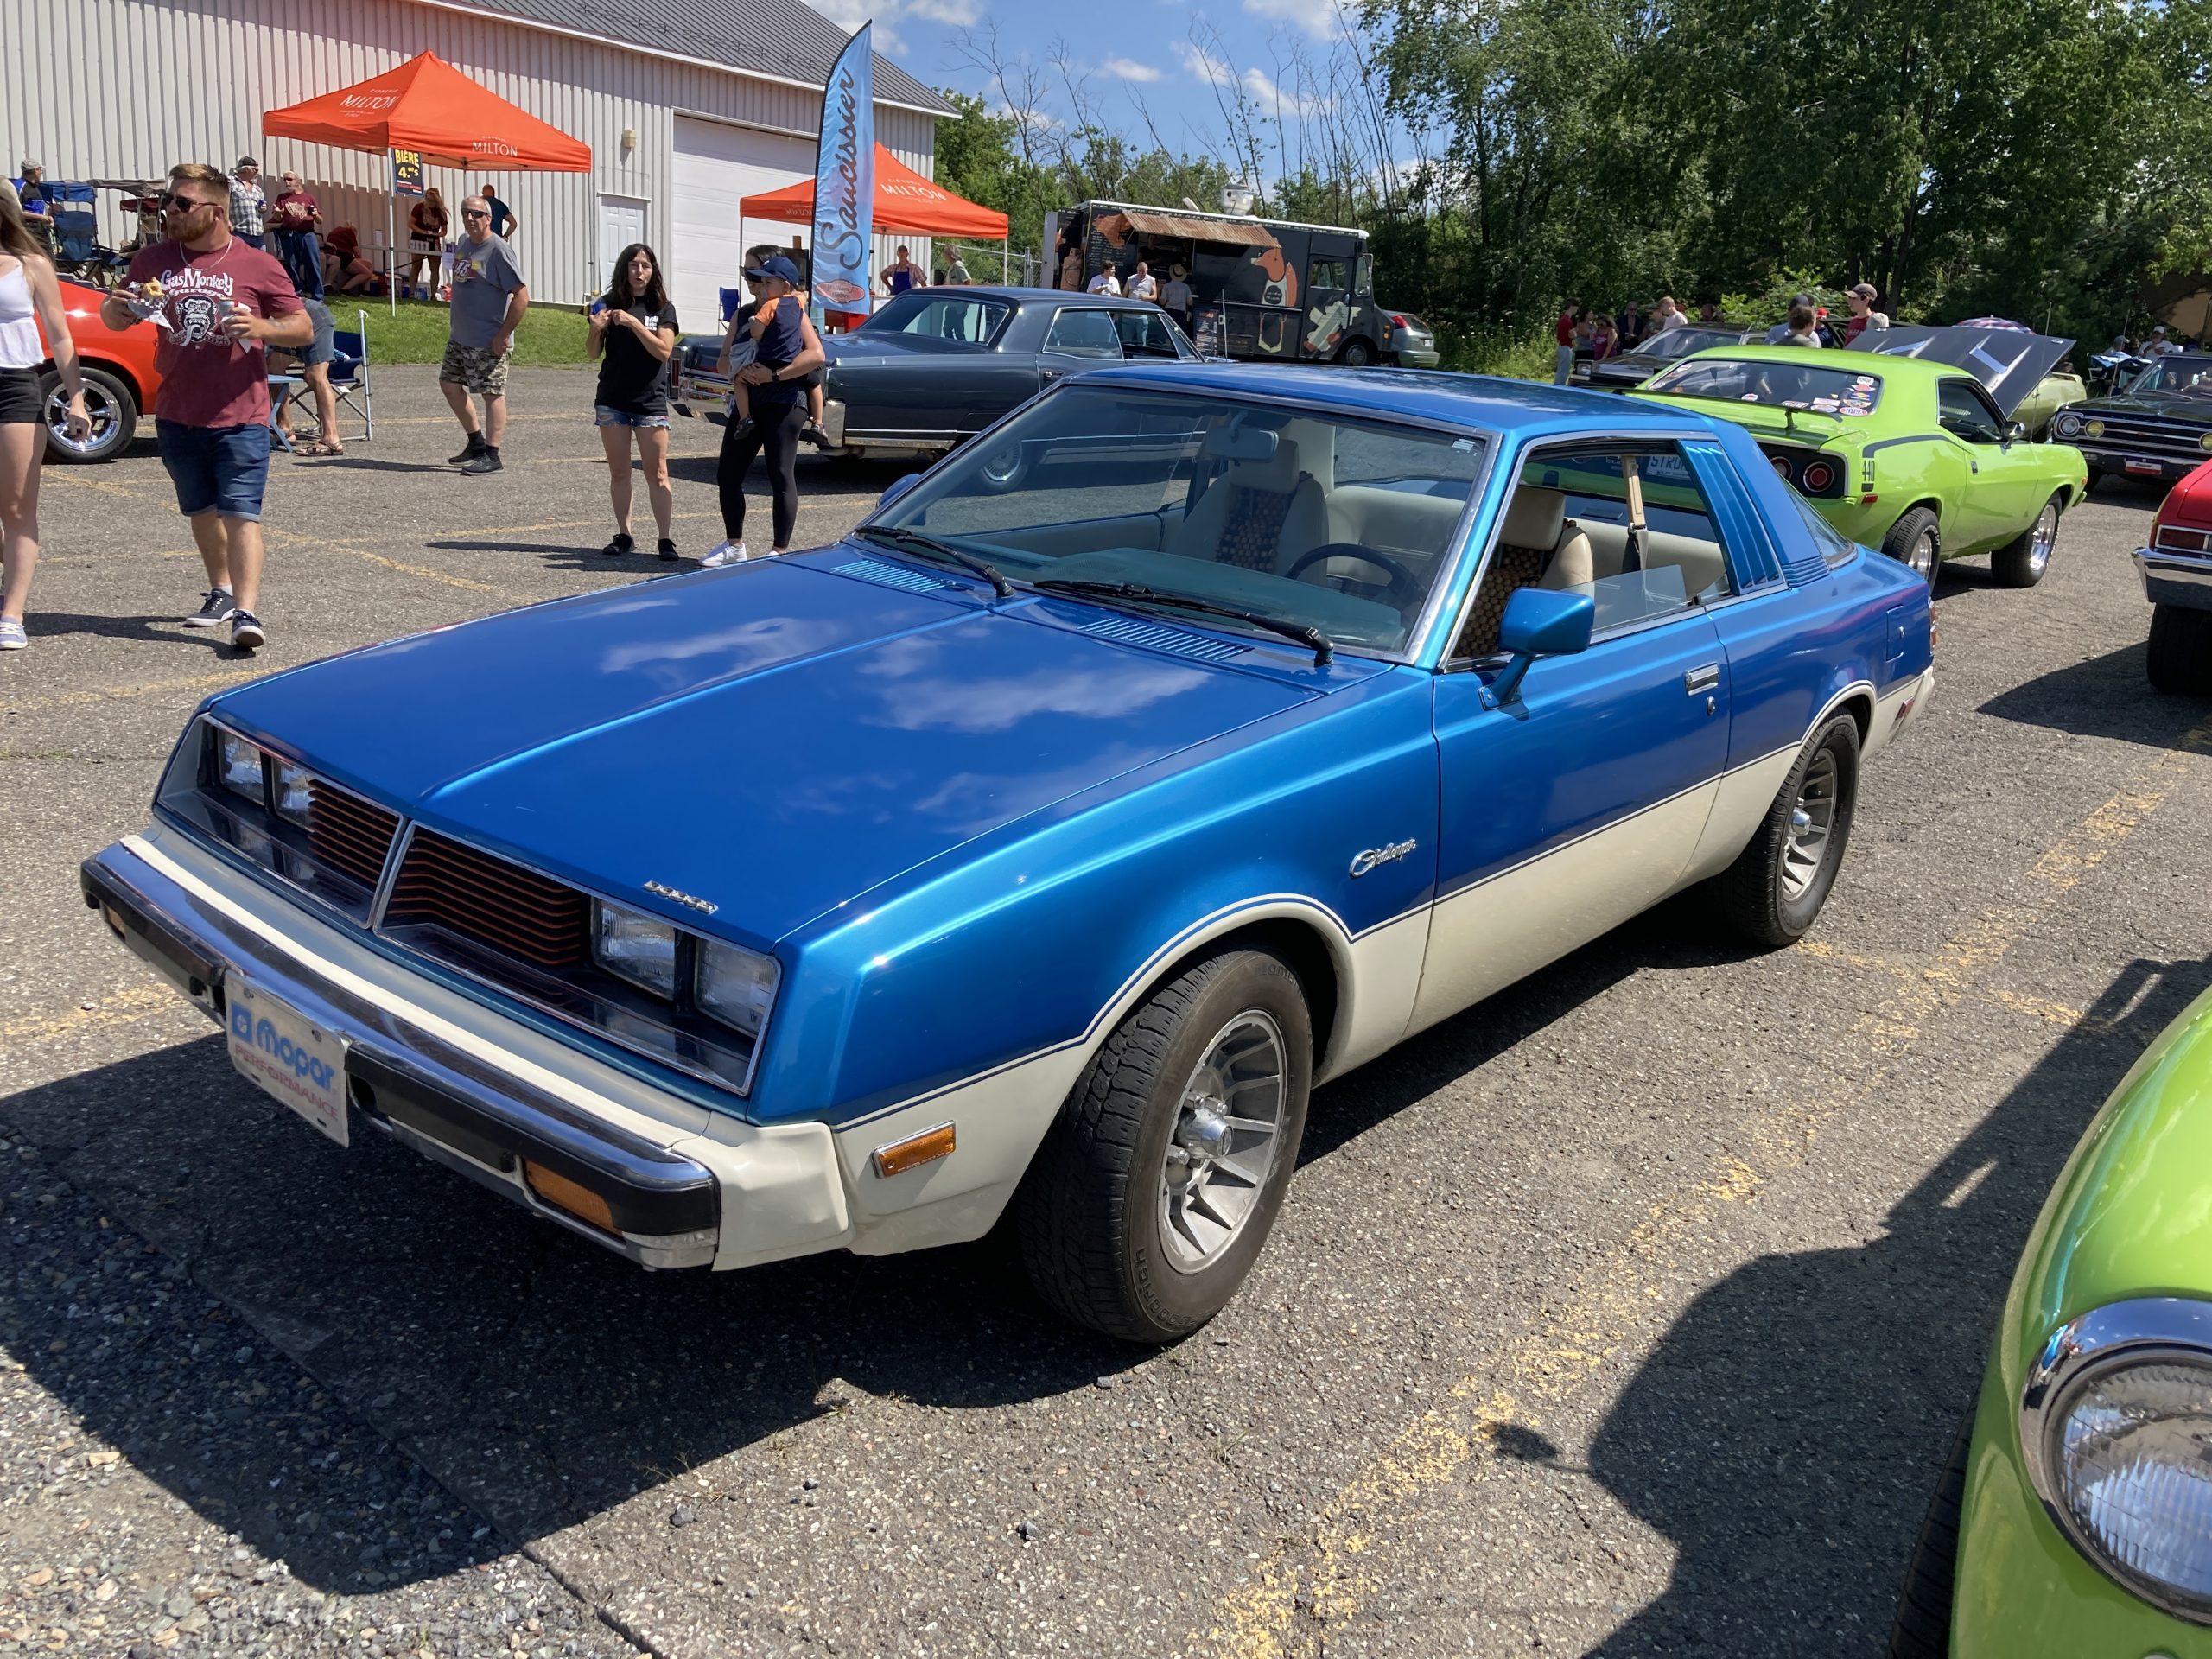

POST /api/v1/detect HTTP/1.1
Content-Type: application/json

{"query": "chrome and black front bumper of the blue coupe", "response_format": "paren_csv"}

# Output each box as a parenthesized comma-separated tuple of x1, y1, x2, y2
(79, 842, 734, 1268)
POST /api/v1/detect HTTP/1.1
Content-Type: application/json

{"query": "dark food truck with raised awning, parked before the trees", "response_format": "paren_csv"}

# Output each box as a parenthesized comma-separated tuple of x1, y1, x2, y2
(1044, 201, 1391, 365)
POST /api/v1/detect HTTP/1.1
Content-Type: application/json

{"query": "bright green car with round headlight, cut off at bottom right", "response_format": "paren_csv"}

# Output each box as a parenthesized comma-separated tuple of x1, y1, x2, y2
(1891, 993, 2212, 1659)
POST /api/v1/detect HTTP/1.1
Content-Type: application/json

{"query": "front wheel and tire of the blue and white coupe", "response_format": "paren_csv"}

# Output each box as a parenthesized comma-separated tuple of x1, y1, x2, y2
(1015, 951, 1314, 1343)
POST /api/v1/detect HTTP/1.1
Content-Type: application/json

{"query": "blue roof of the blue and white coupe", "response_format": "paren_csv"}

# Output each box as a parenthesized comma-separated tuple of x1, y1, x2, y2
(1061, 363, 1710, 435)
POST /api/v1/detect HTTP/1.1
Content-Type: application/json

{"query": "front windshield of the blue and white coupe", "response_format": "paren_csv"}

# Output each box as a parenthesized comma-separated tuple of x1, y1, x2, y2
(869, 383, 1484, 652)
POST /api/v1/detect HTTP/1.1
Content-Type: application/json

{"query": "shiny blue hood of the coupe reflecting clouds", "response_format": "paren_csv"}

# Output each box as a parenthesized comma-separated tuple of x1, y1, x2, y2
(210, 559, 1327, 943)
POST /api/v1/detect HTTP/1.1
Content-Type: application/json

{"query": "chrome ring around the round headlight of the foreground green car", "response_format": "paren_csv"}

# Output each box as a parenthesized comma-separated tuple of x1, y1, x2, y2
(2019, 1296, 2212, 1624)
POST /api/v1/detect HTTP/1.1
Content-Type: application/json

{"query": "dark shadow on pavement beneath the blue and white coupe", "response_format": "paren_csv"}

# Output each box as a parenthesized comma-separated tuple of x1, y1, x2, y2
(0, 905, 1770, 1592)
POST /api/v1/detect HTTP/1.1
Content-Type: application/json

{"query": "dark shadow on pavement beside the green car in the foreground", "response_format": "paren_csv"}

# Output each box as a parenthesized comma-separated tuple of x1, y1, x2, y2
(1591, 963, 2212, 1659)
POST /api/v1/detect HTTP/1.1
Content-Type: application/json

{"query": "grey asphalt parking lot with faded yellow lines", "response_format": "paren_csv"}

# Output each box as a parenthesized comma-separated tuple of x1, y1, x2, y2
(0, 370, 2212, 1659)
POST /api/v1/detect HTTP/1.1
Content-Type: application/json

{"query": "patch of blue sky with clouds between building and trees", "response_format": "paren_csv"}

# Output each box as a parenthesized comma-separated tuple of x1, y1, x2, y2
(814, 0, 1344, 181)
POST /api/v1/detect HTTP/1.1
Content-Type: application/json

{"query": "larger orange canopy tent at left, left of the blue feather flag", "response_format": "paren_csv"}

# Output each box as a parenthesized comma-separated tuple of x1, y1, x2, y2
(261, 51, 591, 309)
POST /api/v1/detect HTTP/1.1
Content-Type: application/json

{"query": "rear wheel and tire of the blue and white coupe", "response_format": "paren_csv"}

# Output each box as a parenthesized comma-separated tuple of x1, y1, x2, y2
(1714, 715, 1858, 947)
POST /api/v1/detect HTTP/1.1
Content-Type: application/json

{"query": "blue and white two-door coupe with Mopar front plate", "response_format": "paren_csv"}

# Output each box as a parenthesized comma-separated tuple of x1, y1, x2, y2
(84, 365, 1933, 1343)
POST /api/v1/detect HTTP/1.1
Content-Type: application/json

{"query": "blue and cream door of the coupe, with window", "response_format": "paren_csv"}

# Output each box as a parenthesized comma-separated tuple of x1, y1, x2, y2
(1414, 438, 1734, 1027)
